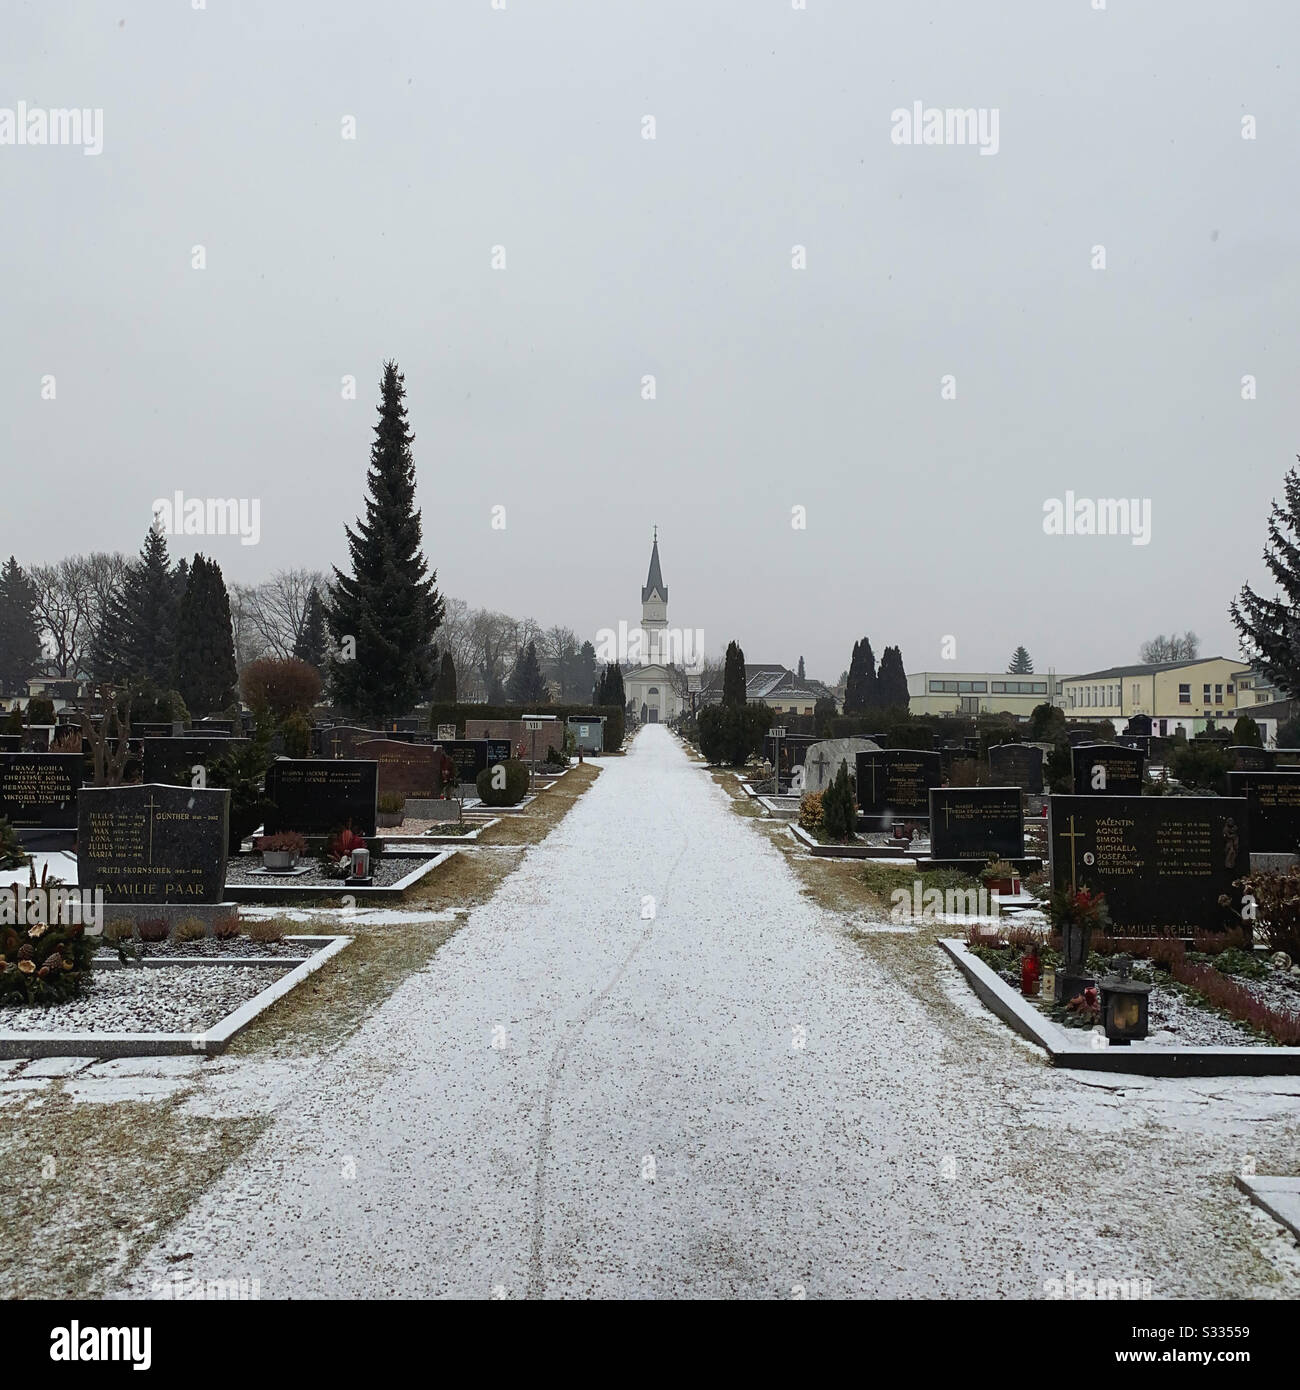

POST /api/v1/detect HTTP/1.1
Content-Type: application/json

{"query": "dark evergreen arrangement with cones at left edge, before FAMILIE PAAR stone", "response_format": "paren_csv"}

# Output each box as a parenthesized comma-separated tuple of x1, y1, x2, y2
(0, 867, 95, 1005)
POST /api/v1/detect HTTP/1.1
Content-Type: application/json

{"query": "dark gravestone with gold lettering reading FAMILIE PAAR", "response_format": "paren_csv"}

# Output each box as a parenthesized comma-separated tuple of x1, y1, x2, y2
(76, 784, 236, 924)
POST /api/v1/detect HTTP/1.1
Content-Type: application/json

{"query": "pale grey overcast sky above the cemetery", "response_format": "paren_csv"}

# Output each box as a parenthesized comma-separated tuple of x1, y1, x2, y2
(0, 0, 1300, 680)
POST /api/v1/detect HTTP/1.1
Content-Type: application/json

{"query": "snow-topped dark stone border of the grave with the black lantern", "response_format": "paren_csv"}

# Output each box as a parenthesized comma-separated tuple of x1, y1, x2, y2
(939, 937, 1300, 1076)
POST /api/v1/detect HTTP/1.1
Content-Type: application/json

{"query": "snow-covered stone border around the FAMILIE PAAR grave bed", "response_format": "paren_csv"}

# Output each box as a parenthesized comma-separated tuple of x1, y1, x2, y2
(0, 935, 353, 1061)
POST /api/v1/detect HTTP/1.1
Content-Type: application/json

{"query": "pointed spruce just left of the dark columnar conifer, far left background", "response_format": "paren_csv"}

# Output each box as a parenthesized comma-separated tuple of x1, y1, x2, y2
(101, 521, 180, 691)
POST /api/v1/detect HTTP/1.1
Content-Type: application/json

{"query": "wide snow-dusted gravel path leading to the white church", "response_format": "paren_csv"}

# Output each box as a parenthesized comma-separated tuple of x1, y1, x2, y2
(125, 726, 1300, 1298)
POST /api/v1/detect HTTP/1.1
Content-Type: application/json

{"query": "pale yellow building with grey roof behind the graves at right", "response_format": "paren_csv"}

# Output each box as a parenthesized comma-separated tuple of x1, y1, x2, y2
(1064, 656, 1251, 734)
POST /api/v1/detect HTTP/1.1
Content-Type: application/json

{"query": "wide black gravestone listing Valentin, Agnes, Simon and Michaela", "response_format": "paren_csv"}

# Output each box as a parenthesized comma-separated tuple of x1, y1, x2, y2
(1048, 796, 1250, 935)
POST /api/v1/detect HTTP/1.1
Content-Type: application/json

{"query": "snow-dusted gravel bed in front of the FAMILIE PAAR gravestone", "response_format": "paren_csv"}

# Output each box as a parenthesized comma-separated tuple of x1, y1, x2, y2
(0, 963, 292, 1033)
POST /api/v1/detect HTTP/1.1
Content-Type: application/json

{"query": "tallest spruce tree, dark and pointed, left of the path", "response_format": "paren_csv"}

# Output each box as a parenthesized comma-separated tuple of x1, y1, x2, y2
(327, 361, 444, 721)
